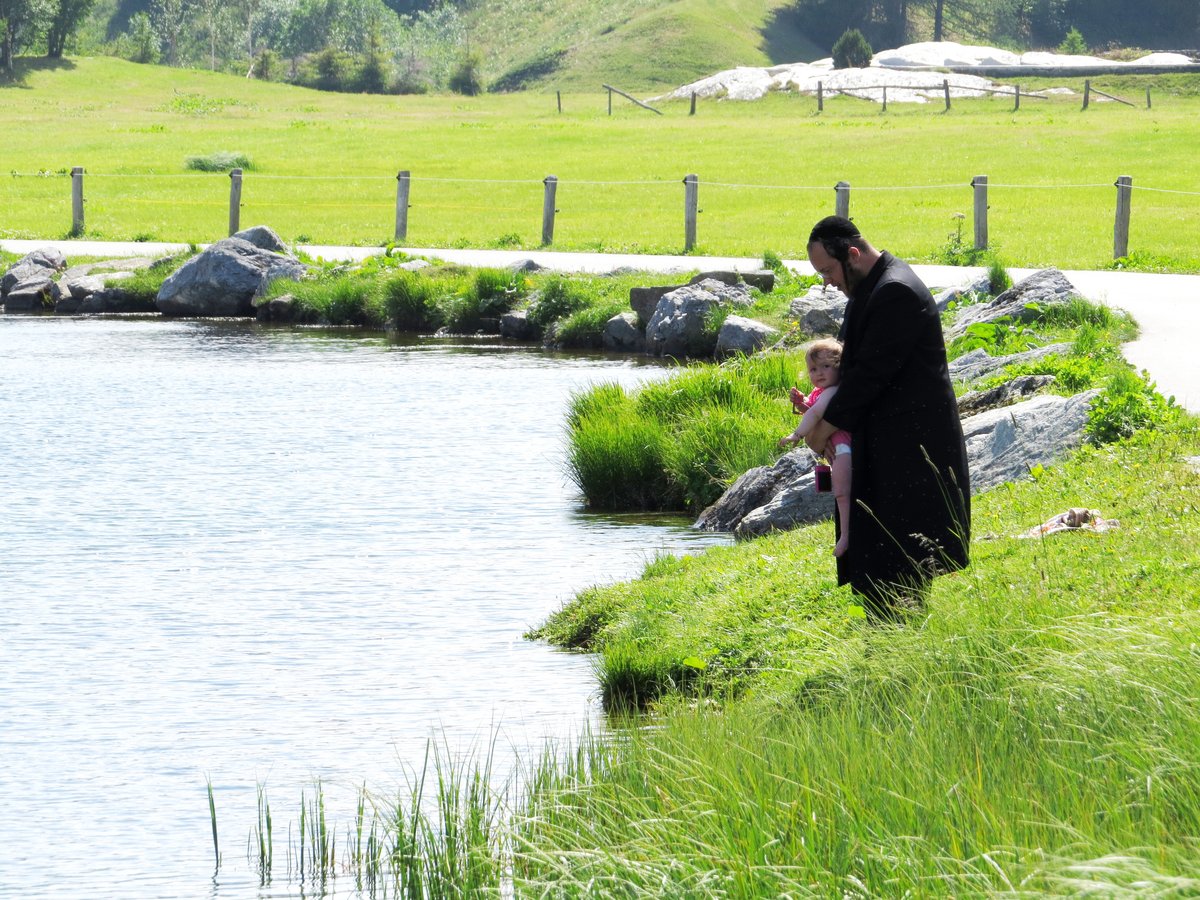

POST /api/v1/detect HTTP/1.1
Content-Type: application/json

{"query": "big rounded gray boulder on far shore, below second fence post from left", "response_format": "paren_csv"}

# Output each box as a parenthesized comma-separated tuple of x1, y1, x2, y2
(157, 229, 307, 317)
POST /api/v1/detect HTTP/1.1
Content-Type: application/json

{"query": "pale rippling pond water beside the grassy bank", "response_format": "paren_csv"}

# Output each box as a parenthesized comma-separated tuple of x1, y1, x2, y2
(0, 316, 725, 900)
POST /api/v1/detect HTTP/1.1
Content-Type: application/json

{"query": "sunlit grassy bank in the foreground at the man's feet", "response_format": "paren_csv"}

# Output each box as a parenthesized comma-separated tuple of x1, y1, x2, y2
(226, 419, 1200, 900)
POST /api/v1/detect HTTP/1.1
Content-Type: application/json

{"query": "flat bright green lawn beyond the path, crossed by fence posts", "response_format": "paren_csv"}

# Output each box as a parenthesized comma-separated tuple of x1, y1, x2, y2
(0, 59, 1200, 271)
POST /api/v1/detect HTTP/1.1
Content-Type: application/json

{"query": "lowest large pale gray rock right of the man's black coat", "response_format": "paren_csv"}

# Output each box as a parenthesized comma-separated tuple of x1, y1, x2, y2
(962, 390, 1099, 493)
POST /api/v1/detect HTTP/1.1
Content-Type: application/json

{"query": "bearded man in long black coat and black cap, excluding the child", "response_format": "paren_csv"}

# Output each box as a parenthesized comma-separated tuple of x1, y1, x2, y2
(808, 216, 971, 619)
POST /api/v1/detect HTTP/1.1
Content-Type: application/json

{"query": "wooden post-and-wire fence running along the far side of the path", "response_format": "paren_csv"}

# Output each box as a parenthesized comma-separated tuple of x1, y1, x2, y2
(11, 166, 1200, 259)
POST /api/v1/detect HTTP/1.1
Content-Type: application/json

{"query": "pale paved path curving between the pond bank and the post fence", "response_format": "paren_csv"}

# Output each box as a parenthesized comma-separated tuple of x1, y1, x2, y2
(0, 240, 1200, 413)
